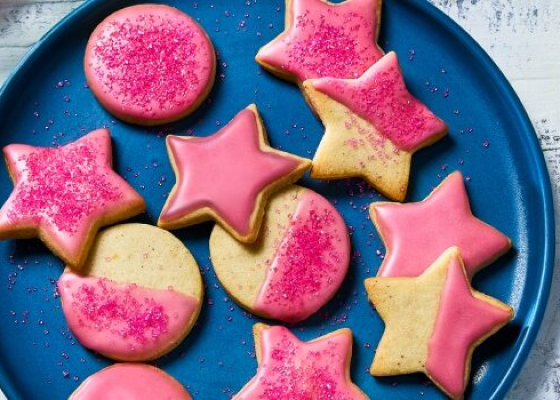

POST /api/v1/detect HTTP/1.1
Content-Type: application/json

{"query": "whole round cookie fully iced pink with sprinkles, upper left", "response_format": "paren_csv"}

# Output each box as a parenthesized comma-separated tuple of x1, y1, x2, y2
(84, 4, 216, 125)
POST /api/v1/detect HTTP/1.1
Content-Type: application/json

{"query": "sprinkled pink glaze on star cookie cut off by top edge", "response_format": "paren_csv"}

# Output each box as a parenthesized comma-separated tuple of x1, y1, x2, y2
(257, 0, 383, 82)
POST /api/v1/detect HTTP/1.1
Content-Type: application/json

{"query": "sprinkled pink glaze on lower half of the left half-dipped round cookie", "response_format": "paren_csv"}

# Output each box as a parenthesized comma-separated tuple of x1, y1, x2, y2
(58, 272, 198, 361)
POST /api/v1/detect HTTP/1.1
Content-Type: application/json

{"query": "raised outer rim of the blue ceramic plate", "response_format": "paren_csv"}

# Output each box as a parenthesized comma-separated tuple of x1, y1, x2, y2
(0, 0, 556, 400)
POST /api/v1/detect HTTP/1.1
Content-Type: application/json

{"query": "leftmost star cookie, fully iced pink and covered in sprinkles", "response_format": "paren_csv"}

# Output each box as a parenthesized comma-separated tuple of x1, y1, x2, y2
(0, 129, 145, 269)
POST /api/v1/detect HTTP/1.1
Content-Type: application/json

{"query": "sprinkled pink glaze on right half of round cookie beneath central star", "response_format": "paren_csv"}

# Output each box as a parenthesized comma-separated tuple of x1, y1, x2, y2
(254, 190, 350, 322)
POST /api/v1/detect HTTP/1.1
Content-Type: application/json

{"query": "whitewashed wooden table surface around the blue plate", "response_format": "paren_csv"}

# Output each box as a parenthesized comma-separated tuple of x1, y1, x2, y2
(0, 0, 560, 400)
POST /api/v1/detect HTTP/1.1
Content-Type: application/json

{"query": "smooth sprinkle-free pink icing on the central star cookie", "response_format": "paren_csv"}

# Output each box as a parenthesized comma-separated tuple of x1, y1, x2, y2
(160, 109, 300, 235)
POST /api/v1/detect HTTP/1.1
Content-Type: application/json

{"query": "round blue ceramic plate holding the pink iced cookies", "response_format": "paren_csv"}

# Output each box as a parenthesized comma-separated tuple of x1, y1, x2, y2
(0, 0, 554, 400)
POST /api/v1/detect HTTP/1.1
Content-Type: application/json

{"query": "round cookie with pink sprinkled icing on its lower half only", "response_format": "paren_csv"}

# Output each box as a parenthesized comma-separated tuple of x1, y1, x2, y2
(58, 224, 204, 361)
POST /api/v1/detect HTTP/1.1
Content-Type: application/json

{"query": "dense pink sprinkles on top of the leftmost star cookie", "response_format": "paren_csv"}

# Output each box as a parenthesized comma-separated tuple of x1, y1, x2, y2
(7, 138, 123, 234)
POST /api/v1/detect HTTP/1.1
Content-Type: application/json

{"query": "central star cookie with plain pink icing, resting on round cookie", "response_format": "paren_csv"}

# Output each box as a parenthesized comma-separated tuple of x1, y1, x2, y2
(158, 105, 311, 243)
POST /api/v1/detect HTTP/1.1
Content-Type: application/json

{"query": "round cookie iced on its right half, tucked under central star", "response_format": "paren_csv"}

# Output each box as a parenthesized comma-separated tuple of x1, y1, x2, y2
(210, 185, 350, 322)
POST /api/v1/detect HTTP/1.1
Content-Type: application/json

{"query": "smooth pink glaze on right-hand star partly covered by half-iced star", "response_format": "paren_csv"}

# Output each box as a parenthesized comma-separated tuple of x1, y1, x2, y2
(372, 172, 510, 277)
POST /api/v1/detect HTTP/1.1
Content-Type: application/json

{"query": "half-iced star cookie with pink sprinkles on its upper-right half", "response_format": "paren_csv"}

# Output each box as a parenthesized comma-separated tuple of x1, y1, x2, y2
(303, 52, 447, 201)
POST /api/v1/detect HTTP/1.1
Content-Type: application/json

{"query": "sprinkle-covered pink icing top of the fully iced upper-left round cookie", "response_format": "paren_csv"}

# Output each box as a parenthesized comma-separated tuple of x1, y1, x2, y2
(90, 9, 212, 113)
